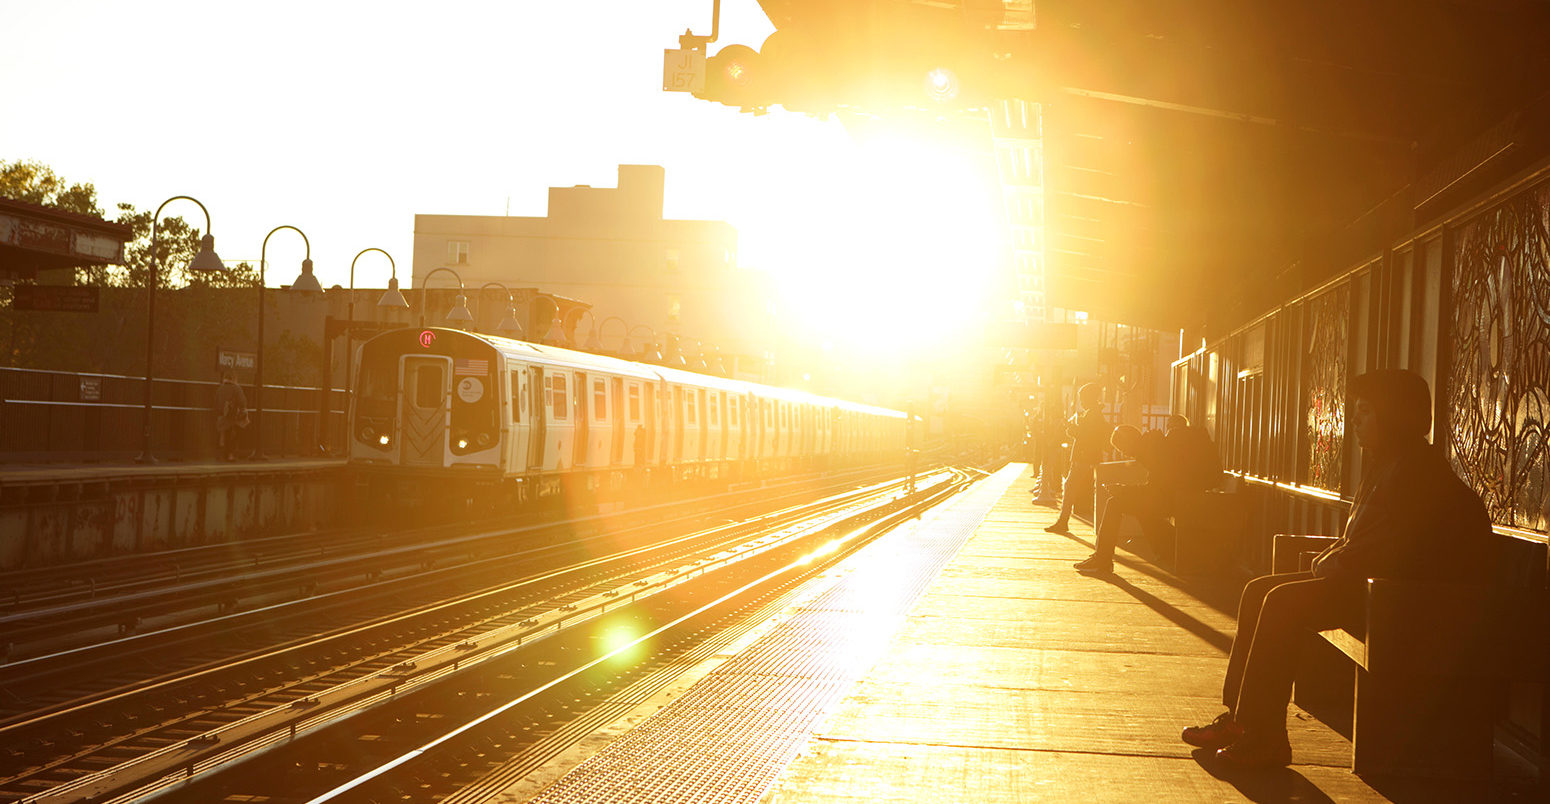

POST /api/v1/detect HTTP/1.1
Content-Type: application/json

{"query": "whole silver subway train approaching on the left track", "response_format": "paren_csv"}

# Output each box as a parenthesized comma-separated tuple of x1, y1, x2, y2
(349, 327, 907, 503)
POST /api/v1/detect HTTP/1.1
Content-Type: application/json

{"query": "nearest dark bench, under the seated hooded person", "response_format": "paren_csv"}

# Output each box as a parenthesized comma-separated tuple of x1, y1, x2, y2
(1271, 534, 1547, 779)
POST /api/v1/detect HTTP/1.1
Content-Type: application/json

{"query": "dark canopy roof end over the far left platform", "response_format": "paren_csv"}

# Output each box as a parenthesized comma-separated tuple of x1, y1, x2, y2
(0, 198, 132, 280)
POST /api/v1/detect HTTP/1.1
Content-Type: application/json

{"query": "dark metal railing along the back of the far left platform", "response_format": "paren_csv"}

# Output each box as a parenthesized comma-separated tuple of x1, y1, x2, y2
(0, 367, 346, 463)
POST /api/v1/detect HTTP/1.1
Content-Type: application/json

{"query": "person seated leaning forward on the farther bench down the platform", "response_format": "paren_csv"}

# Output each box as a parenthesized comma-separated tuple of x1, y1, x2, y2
(1076, 414, 1221, 575)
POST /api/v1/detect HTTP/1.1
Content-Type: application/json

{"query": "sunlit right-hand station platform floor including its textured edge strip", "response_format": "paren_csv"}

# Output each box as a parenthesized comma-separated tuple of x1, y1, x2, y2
(508, 465, 1531, 802)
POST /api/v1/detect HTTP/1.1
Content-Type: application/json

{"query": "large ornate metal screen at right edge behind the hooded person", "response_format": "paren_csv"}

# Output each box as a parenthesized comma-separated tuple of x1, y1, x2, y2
(1448, 184, 1550, 530)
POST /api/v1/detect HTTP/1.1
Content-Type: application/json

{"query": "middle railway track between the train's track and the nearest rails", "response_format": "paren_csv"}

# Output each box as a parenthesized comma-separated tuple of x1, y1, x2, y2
(0, 467, 967, 801)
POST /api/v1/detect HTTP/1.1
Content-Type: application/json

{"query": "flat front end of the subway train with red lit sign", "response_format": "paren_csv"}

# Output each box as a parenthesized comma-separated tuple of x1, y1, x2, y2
(350, 328, 504, 496)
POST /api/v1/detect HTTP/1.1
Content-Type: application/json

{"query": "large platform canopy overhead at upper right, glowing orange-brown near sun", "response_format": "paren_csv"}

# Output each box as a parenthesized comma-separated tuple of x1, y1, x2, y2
(753, 0, 1550, 332)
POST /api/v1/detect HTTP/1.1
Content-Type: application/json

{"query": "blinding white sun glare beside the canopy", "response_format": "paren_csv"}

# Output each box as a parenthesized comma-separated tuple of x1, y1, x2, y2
(747, 121, 1006, 353)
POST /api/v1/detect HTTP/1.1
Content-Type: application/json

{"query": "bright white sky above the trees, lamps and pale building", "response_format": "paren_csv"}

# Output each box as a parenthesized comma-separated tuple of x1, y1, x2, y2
(0, 0, 995, 348)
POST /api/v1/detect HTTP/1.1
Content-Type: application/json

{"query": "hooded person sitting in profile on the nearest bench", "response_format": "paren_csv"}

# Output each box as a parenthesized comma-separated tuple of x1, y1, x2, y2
(1183, 369, 1496, 767)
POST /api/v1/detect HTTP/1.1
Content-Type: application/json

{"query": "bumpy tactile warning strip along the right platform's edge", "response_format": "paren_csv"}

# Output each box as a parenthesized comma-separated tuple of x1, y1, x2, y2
(533, 468, 1021, 802)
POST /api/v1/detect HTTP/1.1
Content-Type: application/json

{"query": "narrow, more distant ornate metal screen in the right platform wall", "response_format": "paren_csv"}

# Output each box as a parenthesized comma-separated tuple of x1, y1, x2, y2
(1302, 285, 1350, 491)
